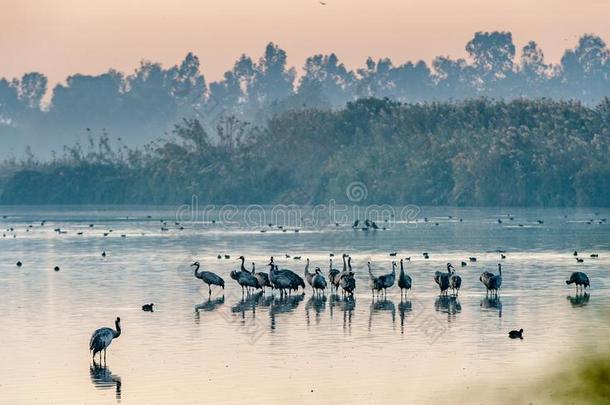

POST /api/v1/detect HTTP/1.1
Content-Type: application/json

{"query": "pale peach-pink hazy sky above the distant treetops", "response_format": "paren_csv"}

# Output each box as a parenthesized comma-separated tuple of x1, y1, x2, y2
(0, 0, 610, 83)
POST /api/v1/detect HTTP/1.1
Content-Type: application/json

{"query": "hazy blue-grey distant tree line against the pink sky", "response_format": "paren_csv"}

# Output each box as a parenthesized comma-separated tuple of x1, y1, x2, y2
(0, 32, 610, 156)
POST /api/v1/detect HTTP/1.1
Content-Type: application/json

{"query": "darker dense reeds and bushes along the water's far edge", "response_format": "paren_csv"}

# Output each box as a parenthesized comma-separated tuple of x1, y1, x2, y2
(0, 98, 610, 206)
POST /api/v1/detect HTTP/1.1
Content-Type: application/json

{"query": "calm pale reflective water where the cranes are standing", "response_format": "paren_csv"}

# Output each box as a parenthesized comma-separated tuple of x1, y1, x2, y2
(0, 207, 610, 404)
